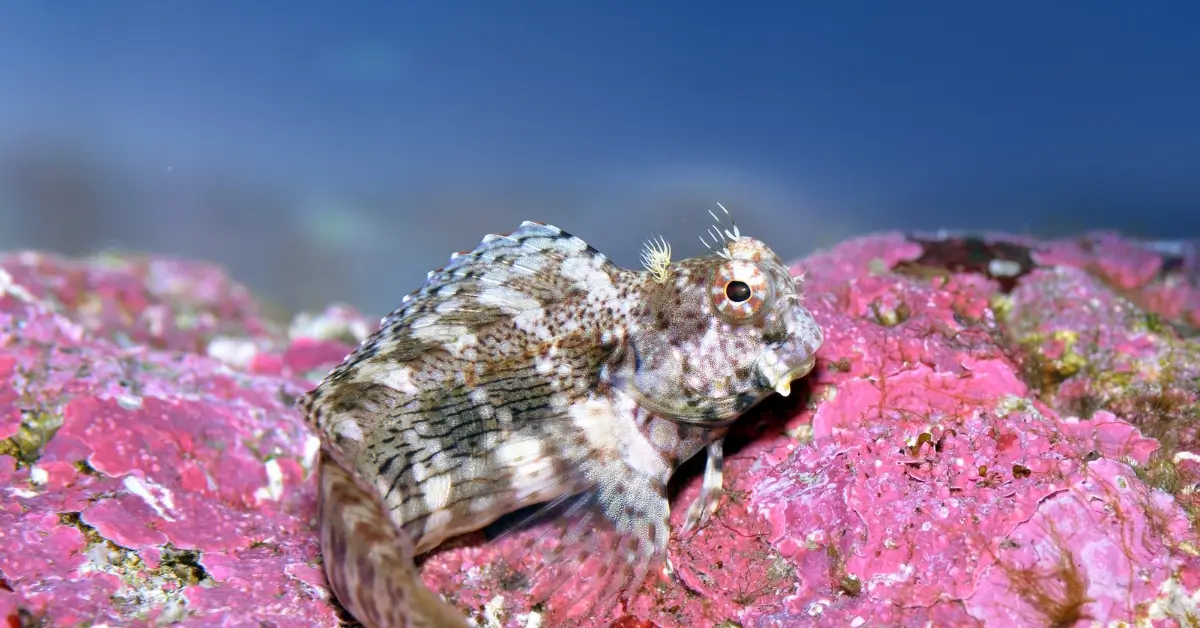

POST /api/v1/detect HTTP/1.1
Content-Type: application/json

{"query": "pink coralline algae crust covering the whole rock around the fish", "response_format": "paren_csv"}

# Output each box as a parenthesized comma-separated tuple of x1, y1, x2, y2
(0, 233, 1200, 628)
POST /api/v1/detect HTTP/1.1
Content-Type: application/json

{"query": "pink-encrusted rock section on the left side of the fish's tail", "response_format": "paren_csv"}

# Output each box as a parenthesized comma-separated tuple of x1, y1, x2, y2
(0, 253, 350, 626)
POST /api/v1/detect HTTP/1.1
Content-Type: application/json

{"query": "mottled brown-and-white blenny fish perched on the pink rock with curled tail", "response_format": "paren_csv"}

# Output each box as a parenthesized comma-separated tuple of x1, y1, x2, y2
(300, 205, 823, 628)
